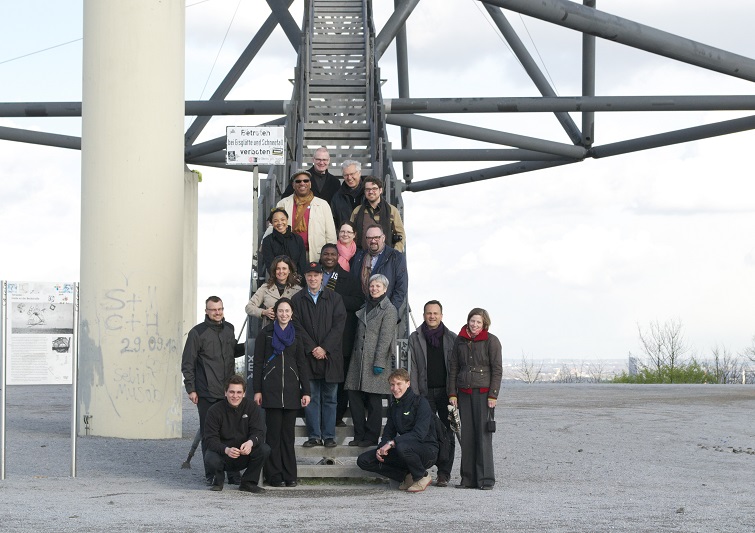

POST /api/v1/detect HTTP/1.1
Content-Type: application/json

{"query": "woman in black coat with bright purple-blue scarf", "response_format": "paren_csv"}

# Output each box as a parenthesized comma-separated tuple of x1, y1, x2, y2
(254, 298, 310, 487)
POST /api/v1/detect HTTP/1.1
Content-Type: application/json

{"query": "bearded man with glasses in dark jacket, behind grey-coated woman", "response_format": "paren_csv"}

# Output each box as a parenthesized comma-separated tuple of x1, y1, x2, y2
(351, 224, 409, 318)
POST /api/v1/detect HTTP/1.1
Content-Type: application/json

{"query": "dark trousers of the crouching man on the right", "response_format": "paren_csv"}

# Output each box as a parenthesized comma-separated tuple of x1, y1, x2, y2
(357, 439, 438, 482)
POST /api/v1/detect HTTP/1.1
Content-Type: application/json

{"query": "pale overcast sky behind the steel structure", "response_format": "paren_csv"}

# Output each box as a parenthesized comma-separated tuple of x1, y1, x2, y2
(0, 0, 755, 360)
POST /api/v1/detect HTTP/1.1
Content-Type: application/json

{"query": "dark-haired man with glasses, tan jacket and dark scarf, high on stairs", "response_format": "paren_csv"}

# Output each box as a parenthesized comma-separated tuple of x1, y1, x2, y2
(351, 176, 406, 250)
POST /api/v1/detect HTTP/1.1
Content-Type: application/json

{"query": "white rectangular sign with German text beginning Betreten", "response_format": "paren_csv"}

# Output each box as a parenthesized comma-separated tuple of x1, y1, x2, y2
(225, 126, 286, 165)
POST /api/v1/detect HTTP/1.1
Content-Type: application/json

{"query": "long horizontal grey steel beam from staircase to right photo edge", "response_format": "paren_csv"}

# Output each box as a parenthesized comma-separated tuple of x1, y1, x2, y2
(383, 95, 755, 115)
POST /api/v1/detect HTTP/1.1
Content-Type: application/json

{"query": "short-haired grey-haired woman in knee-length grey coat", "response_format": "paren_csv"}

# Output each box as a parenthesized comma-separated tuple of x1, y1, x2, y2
(343, 274, 398, 448)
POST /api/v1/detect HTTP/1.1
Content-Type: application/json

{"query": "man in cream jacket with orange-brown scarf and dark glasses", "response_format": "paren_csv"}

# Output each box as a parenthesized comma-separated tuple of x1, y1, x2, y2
(276, 170, 338, 263)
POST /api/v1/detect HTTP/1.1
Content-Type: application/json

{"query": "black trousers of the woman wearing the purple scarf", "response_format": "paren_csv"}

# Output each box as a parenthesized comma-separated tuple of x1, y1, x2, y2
(265, 409, 298, 483)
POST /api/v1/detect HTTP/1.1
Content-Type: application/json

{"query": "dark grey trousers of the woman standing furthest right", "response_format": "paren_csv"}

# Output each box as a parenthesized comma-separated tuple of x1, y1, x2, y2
(459, 389, 495, 487)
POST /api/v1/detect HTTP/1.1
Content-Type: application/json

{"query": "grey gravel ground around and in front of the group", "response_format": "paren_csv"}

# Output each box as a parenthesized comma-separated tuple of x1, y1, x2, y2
(0, 384, 755, 533)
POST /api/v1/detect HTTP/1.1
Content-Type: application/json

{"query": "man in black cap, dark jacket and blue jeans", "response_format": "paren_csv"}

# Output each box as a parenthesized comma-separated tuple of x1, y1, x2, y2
(291, 262, 346, 448)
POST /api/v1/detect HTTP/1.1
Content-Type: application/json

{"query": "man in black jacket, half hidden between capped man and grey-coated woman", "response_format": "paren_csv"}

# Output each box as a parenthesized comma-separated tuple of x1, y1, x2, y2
(320, 244, 364, 426)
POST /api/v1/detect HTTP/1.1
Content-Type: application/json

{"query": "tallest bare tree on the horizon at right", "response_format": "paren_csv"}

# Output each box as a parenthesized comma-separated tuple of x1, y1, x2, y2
(637, 320, 689, 383)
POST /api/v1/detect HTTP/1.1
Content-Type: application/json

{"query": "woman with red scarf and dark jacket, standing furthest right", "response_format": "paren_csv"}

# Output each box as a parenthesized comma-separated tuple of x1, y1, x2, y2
(448, 307, 503, 490)
